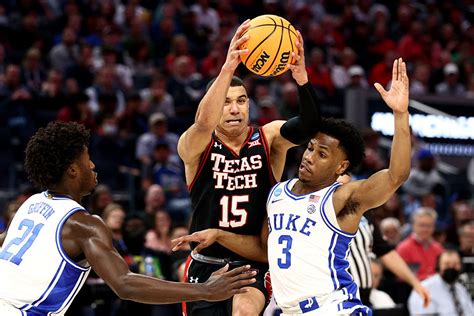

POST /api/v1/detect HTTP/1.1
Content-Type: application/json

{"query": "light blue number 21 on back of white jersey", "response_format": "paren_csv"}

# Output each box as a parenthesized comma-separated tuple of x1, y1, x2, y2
(0, 219, 44, 265)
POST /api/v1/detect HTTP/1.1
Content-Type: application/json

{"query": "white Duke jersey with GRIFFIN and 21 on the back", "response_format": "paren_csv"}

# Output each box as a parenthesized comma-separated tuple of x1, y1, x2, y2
(0, 192, 90, 316)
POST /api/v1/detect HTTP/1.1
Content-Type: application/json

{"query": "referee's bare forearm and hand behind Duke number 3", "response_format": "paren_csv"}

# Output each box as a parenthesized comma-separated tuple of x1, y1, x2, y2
(380, 250, 431, 307)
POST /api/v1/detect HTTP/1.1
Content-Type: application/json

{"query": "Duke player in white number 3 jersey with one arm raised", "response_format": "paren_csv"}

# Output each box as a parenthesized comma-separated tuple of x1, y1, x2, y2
(174, 58, 429, 315)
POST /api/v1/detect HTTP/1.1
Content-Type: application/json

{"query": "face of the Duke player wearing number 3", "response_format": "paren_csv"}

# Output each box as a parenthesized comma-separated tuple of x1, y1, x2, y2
(298, 133, 349, 185)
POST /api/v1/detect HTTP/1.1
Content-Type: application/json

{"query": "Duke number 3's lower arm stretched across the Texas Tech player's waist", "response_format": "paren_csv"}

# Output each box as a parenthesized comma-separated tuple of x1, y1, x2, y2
(171, 220, 268, 262)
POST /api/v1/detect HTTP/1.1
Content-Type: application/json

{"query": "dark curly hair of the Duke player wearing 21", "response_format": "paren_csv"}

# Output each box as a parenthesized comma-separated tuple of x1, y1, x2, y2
(25, 121, 90, 189)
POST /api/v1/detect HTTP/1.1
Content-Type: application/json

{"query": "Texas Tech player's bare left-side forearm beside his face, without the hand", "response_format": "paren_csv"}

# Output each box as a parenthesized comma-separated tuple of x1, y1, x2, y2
(195, 67, 234, 130)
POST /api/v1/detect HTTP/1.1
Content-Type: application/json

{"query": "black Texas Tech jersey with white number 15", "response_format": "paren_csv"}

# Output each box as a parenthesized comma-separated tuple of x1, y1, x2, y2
(189, 127, 275, 260)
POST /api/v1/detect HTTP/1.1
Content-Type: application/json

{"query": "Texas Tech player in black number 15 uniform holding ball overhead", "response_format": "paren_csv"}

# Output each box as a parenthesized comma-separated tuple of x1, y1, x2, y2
(178, 21, 320, 315)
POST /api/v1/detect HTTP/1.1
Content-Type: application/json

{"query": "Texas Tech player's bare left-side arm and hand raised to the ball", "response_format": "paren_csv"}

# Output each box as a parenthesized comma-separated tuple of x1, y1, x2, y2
(178, 20, 250, 168)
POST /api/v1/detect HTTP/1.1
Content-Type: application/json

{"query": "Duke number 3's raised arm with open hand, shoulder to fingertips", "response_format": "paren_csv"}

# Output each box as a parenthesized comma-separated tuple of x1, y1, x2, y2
(334, 58, 411, 231)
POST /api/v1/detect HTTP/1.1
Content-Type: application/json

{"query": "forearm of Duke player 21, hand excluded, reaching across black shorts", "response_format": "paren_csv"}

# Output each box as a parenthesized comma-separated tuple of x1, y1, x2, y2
(111, 273, 206, 304)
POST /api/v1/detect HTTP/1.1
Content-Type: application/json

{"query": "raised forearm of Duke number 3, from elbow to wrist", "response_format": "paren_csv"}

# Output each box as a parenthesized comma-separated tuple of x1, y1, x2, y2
(388, 111, 411, 186)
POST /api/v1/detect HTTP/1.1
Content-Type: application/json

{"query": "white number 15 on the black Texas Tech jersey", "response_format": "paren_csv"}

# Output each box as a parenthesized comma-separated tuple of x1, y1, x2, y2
(219, 195, 249, 228)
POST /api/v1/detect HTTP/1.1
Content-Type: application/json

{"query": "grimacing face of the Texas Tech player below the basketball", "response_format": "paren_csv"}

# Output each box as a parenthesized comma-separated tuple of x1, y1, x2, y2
(218, 86, 249, 135)
